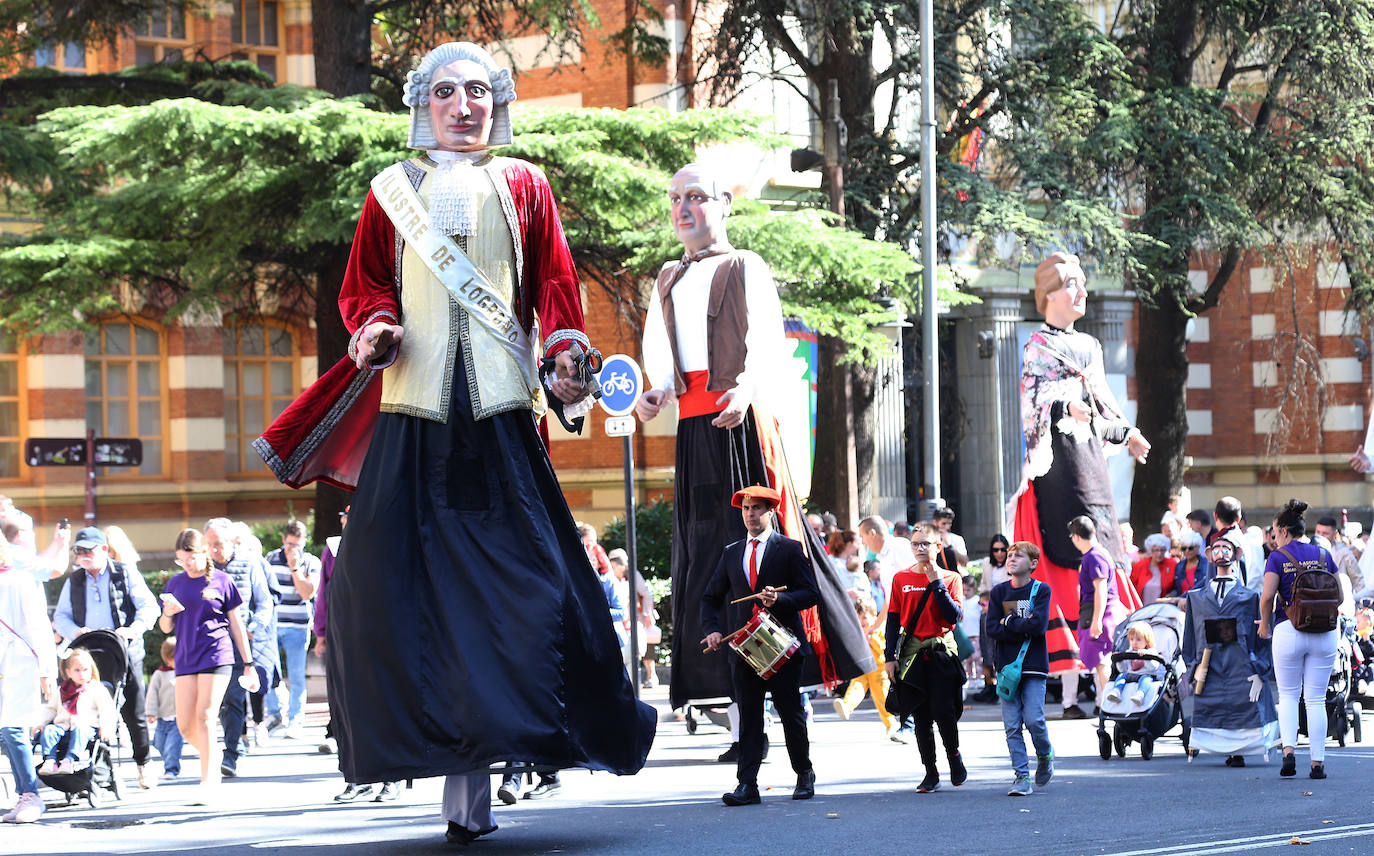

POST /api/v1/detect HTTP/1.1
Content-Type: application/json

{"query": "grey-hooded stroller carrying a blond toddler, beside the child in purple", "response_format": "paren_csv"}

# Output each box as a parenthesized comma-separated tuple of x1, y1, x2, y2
(1098, 603, 1189, 761)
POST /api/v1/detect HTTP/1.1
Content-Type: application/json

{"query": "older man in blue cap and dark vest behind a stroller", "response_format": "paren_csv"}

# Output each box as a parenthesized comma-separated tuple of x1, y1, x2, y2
(52, 526, 162, 787)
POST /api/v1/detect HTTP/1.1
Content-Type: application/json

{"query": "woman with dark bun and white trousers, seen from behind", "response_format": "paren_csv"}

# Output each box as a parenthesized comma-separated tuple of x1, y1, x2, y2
(1260, 499, 1337, 779)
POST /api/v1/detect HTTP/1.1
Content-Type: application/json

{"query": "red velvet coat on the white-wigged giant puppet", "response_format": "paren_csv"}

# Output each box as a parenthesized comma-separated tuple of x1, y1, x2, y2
(253, 159, 584, 489)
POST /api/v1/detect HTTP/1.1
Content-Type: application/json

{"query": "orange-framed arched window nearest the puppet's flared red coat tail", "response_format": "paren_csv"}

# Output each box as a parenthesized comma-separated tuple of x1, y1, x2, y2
(224, 322, 301, 474)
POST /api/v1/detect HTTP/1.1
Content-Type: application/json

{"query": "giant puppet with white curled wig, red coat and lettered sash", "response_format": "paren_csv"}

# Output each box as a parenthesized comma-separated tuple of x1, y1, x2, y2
(257, 43, 655, 844)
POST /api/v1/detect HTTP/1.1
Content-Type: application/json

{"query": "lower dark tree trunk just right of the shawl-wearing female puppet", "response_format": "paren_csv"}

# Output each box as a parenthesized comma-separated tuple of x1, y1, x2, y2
(1131, 302, 1189, 544)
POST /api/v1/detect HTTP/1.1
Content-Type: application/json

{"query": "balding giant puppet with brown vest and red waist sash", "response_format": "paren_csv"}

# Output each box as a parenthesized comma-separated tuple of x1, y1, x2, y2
(635, 164, 877, 706)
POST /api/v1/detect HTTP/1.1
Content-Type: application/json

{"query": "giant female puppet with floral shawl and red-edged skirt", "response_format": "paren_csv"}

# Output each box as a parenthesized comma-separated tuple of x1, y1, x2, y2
(1010, 253, 1150, 714)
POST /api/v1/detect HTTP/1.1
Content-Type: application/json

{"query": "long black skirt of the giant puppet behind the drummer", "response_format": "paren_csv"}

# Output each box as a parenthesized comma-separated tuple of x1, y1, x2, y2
(669, 408, 877, 708)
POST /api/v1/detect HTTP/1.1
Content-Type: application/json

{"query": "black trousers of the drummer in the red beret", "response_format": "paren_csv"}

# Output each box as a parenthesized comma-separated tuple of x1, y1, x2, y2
(730, 654, 811, 785)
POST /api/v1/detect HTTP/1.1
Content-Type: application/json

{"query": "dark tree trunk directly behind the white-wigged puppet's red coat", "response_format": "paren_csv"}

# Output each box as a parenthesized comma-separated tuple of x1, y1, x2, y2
(311, 0, 372, 543)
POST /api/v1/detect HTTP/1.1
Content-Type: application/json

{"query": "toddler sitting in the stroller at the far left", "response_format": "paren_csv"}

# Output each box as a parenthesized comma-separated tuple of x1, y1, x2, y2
(38, 649, 115, 775)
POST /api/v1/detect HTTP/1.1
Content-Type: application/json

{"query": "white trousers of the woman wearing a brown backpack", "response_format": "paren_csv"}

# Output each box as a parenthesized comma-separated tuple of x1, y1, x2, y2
(1274, 621, 1336, 763)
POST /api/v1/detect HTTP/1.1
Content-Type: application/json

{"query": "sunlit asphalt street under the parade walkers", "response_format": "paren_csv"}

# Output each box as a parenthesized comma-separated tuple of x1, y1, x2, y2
(0, 691, 1374, 856)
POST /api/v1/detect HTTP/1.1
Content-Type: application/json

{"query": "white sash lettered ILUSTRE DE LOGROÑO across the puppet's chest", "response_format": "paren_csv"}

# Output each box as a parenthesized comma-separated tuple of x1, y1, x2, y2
(372, 164, 534, 367)
